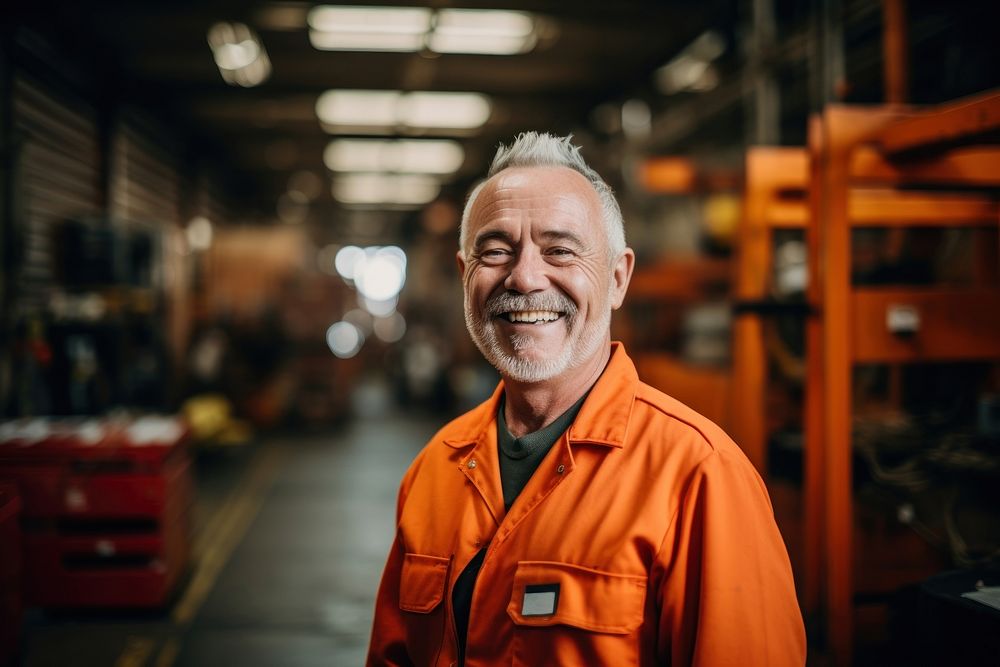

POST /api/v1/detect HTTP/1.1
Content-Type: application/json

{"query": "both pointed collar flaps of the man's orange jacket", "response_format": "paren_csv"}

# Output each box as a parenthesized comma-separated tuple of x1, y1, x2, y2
(444, 342, 639, 449)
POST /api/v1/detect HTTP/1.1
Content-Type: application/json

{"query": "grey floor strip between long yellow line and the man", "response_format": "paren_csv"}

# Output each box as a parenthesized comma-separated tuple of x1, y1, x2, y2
(176, 418, 435, 667)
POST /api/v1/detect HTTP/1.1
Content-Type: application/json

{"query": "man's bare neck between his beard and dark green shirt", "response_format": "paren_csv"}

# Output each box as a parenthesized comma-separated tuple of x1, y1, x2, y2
(504, 343, 611, 438)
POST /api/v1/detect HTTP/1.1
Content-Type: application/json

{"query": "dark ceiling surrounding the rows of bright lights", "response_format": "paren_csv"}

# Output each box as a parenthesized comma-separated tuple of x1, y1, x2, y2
(1, 0, 736, 235)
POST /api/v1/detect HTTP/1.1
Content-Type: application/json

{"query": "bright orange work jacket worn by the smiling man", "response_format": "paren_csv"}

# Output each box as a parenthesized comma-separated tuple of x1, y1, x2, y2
(368, 343, 805, 667)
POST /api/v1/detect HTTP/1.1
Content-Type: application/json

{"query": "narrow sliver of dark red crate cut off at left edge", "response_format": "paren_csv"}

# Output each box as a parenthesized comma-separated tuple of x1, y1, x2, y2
(0, 482, 21, 665)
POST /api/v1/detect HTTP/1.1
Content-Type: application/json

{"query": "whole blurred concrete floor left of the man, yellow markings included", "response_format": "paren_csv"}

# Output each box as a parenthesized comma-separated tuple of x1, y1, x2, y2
(20, 414, 434, 667)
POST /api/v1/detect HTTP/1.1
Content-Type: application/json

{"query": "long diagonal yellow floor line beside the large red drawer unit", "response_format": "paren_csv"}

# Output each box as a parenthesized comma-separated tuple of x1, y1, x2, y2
(172, 447, 285, 625)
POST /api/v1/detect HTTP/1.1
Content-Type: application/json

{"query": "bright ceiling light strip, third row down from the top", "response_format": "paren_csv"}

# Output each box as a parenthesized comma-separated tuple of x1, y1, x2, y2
(323, 139, 465, 175)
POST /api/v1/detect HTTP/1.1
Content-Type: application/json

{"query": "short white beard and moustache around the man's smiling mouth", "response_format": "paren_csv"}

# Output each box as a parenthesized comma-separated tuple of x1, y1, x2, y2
(465, 285, 612, 383)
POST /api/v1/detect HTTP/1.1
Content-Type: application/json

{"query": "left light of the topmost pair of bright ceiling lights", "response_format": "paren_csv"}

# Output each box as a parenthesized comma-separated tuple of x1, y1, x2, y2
(307, 6, 432, 51)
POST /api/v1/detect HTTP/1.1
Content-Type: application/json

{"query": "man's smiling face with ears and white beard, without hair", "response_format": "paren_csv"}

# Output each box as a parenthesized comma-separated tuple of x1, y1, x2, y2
(459, 167, 632, 382)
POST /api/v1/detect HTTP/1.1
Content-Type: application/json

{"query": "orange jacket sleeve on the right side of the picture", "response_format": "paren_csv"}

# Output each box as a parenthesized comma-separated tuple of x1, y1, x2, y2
(657, 447, 806, 667)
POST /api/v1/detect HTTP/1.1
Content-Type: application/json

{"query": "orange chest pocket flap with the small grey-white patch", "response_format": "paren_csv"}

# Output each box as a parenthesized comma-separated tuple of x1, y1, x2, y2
(507, 561, 646, 634)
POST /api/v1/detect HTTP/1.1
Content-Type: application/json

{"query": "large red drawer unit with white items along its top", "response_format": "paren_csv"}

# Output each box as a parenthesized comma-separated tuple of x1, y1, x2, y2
(0, 417, 192, 607)
